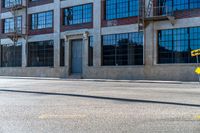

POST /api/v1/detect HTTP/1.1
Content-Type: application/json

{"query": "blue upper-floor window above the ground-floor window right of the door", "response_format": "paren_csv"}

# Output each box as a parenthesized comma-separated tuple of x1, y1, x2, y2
(106, 0, 139, 20)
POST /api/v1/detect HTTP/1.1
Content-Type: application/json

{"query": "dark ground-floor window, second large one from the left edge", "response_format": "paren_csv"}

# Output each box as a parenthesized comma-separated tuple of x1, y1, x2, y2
(28, 41, 54, 67)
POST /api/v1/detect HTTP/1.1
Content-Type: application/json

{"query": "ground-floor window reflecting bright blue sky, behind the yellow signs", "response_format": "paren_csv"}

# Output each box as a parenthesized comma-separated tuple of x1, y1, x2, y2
(158, 27, 200, 64)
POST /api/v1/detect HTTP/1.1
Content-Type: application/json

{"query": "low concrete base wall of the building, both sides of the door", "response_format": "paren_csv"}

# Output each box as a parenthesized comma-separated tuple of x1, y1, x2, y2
(0, 65, 198, 81)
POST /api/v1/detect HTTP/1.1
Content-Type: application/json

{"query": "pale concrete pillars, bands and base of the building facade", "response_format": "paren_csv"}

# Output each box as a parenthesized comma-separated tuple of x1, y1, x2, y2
(0, 0, 200, 81)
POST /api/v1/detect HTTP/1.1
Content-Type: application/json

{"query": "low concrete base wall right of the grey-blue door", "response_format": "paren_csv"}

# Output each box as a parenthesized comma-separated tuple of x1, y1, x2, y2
(84, 65, 198, 81)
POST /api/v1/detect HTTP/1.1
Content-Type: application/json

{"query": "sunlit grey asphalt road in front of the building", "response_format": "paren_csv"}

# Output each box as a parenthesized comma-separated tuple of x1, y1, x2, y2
(0, 77, 200, 133)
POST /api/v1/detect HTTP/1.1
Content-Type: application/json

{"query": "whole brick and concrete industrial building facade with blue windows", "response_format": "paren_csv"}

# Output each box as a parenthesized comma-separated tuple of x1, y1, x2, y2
(0, 0, 200, 81)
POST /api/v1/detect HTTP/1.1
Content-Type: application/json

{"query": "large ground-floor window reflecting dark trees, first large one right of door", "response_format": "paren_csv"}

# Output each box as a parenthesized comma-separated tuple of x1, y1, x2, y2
(102, 32, 143, 65)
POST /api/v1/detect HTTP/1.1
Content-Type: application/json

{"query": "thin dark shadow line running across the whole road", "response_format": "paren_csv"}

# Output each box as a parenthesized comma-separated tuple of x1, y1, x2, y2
(0, 89, 200, 107)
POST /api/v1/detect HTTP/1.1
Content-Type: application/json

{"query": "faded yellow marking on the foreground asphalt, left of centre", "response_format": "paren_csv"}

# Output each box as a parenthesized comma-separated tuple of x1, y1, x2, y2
(38, 114, 86, 119)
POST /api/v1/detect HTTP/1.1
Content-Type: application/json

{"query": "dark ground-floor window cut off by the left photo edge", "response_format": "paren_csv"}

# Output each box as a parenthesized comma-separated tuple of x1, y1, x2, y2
(0, 43, 22, 67)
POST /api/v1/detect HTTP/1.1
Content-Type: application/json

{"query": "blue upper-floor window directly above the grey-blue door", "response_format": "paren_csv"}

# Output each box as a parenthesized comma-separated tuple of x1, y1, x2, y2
(64, 4, 92, 25)
